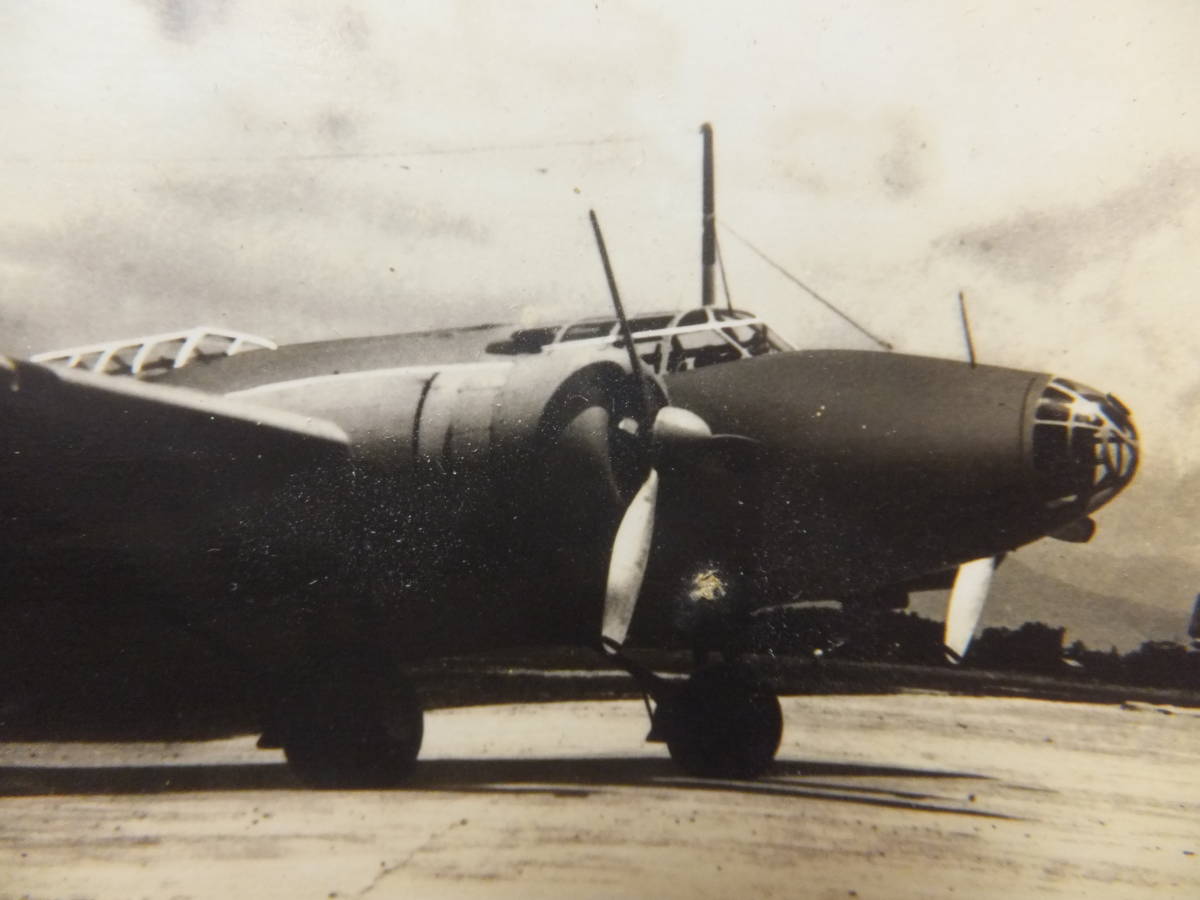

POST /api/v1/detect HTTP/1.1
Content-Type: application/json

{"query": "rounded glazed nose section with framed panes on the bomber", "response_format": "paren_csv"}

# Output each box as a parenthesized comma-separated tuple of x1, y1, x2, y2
(1033, 378, 1138, 512)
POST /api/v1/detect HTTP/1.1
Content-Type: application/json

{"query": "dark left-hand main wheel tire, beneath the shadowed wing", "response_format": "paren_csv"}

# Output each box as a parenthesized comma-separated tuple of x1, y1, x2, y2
(281, 665, 425, 788)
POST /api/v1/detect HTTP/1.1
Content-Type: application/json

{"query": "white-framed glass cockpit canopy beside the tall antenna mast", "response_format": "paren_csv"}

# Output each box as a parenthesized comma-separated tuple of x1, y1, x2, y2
(487, 306, 791, 374)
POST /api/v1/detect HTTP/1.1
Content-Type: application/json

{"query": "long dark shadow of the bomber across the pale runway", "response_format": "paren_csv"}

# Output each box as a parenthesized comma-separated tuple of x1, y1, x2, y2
(0, 756, 1009, 818)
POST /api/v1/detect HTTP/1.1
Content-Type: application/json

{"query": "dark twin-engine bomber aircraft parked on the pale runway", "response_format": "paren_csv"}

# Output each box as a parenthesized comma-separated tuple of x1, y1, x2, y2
(0, 128, 1136, 785)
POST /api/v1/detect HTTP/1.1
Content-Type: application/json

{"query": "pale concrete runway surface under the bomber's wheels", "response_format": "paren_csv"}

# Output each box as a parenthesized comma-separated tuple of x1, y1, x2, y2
(0, 694, 1200, 900)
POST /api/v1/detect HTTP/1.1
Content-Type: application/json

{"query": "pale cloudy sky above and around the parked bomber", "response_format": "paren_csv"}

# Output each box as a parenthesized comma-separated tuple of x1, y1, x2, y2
(0, 0, 1200, 648)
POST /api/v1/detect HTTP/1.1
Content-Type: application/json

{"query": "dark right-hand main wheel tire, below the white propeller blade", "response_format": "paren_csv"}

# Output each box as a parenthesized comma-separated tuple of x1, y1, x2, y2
(660, 664, 784, 779)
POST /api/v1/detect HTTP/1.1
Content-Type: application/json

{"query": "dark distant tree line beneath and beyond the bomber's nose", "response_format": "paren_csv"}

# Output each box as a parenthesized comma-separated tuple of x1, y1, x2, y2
(750, 605, 1200, 690)
